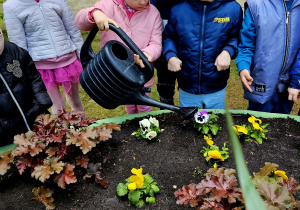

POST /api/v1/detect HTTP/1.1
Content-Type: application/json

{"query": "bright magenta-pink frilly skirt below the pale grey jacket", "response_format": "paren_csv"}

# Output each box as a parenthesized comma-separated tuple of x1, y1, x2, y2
(38, 59, 82, 95)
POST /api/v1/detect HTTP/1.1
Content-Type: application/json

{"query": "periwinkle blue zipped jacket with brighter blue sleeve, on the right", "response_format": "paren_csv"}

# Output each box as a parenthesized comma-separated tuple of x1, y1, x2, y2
(236, 0, 300, 104)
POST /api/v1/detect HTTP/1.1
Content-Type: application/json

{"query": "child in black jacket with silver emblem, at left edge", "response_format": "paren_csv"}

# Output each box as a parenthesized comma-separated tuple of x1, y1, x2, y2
(0, 30, 52, 147)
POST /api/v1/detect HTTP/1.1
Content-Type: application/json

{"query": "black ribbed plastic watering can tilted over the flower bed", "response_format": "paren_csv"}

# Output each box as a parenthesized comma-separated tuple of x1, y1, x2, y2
(79, 24, 198, 119)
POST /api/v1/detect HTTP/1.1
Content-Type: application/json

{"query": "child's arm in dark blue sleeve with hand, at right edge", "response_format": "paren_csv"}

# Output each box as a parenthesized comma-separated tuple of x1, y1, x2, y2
(288, 50, 300, 104)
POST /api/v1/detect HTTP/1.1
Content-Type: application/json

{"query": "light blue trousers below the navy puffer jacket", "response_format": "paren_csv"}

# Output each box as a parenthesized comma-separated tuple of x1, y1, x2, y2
(179, 88, 226, 109)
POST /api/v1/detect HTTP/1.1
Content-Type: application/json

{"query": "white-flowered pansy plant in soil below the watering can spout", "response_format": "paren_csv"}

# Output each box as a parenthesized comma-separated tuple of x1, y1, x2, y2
(131, 117, 161, 140)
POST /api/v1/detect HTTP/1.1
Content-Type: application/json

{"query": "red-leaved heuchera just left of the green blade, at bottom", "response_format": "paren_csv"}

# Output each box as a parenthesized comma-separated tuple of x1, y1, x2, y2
(174, 168, 244, 210)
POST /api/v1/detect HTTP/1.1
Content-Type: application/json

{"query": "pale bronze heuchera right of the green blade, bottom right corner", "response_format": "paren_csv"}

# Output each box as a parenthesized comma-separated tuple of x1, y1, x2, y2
(251, 162, 300, 209)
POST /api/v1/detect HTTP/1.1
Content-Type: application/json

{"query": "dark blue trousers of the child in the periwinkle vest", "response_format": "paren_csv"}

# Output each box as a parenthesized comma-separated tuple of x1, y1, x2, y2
(248, 91, 294, 114)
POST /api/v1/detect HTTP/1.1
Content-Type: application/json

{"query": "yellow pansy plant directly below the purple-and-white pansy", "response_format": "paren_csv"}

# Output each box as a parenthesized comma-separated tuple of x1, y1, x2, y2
(200, 135, 229, 163)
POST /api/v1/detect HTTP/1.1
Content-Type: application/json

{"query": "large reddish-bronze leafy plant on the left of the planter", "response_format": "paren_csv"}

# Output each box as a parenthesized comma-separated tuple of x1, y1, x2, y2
(0, 111, 120, 208)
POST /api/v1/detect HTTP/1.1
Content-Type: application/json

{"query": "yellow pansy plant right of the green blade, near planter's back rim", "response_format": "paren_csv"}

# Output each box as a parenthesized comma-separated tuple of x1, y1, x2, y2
(233, 116, 268, 144)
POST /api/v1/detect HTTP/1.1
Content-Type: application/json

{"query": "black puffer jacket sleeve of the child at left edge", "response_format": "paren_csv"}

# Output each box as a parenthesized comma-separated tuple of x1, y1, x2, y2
(20, 50, 52, 122)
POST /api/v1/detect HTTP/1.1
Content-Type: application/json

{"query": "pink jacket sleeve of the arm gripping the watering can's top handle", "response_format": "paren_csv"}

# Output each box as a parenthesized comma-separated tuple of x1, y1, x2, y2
(75, 0, 113, 31)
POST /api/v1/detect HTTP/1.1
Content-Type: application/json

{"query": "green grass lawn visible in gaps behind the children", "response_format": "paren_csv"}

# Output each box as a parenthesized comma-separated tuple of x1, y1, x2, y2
(0, 23, 300, 119)
